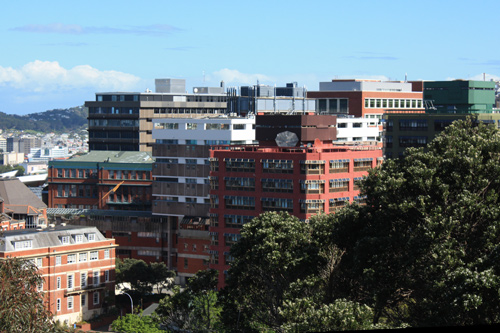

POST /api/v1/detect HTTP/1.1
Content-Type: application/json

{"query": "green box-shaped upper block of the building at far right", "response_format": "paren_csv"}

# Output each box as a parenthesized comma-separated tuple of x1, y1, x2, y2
(423, 80, 495, 113)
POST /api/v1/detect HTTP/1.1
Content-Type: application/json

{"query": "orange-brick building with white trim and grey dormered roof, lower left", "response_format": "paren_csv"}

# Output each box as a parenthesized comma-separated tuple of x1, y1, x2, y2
(0, 225, 116, 324)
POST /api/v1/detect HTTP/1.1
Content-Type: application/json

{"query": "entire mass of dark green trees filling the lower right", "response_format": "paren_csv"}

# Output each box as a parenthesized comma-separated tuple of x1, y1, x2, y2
(220, 117, 500, 331)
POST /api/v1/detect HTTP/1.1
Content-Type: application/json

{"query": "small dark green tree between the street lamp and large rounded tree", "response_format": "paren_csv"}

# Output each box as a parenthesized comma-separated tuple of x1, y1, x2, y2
(156, 269, 222, 332)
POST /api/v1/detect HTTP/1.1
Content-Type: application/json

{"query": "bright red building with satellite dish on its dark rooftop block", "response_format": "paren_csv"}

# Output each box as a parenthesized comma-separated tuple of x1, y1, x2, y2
(210, 116, 382, 286)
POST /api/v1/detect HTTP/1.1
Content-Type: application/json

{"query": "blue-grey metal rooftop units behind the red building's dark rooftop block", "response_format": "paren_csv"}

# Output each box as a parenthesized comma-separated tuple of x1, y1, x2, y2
(227, 82, 316, 116)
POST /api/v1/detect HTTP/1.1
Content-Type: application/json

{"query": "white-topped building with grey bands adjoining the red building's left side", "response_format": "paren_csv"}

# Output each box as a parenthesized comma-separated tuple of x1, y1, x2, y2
(153, 115, 255, 283)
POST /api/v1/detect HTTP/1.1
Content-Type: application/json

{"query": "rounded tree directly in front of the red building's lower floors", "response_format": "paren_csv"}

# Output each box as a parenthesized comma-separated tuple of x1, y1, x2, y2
(222, 212, 324, 331)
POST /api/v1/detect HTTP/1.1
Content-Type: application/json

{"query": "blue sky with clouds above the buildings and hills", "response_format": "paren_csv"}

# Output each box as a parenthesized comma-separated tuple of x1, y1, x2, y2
(0, 0, 500, 115)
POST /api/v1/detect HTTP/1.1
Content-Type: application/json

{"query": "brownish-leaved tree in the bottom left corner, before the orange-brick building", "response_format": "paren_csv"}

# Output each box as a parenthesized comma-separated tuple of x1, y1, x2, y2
(0, 258, 54, 332)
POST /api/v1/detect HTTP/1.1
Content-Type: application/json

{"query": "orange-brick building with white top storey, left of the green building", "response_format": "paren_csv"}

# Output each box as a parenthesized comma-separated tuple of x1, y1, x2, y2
(307, 79, 424, 119)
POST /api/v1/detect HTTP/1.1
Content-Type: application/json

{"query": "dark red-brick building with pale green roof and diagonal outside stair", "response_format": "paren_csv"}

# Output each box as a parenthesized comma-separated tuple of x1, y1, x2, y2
(48, 151, 153, 211)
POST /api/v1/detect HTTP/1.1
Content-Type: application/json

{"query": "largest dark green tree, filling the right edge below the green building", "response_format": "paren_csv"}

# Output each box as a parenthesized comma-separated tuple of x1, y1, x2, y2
(325, 117, 500, 327)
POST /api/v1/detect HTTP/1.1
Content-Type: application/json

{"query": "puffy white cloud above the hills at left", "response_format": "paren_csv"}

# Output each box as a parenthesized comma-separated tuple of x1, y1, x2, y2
(0, 60, 141, 92)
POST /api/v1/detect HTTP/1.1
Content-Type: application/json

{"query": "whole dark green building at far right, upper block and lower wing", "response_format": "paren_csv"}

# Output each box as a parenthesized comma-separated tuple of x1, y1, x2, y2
(383, 80, 500, 158)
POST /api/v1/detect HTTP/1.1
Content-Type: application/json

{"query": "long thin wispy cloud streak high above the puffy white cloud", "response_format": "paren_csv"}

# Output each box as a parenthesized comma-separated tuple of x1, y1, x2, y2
(11, 23, 182, 35)
